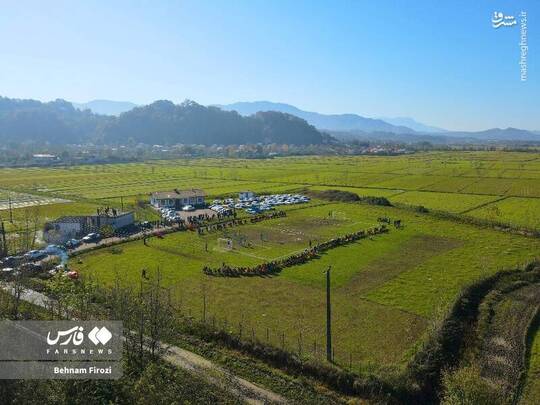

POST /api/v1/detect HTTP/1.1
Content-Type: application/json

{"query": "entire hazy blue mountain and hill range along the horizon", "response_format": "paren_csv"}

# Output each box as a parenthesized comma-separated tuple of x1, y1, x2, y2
(0, 97, 540, 145)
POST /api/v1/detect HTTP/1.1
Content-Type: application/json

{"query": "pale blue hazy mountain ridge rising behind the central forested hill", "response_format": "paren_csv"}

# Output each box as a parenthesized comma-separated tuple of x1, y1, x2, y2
(216, 101, 415, 134)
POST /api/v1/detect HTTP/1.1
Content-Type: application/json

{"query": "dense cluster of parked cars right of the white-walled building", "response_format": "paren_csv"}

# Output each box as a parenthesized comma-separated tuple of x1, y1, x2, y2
(210, 194, 310, 215)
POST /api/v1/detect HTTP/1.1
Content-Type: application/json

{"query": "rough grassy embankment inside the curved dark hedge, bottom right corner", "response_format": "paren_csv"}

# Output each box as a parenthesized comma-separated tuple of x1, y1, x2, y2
(436, 262, 540, 404)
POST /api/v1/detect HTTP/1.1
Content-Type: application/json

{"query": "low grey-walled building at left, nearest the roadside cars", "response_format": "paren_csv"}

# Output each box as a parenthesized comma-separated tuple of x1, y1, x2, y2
(43, 210, 135, 243)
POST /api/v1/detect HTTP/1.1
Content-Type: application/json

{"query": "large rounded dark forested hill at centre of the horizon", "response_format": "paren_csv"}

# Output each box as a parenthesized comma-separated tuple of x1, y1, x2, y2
(104, 101, 328, 145)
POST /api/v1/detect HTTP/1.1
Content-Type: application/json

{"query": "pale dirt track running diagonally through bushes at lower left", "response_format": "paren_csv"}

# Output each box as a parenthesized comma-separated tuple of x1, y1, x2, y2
(0, 283, 288, 404)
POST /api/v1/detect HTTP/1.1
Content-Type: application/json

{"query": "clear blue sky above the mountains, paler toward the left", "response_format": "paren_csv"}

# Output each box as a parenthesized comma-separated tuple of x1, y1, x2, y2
(0, 0, 540, 130)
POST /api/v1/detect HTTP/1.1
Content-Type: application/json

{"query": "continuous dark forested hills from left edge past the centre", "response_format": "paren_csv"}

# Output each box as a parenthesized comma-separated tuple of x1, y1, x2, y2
(0, 97, 331, 145)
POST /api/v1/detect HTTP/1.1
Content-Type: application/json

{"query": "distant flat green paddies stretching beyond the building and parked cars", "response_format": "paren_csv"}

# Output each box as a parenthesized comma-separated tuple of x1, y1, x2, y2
(0, 152, 540, 229)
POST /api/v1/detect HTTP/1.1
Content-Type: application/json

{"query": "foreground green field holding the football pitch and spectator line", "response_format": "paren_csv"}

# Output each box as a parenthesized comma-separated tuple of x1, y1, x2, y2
(72, 203, 540, 366)
